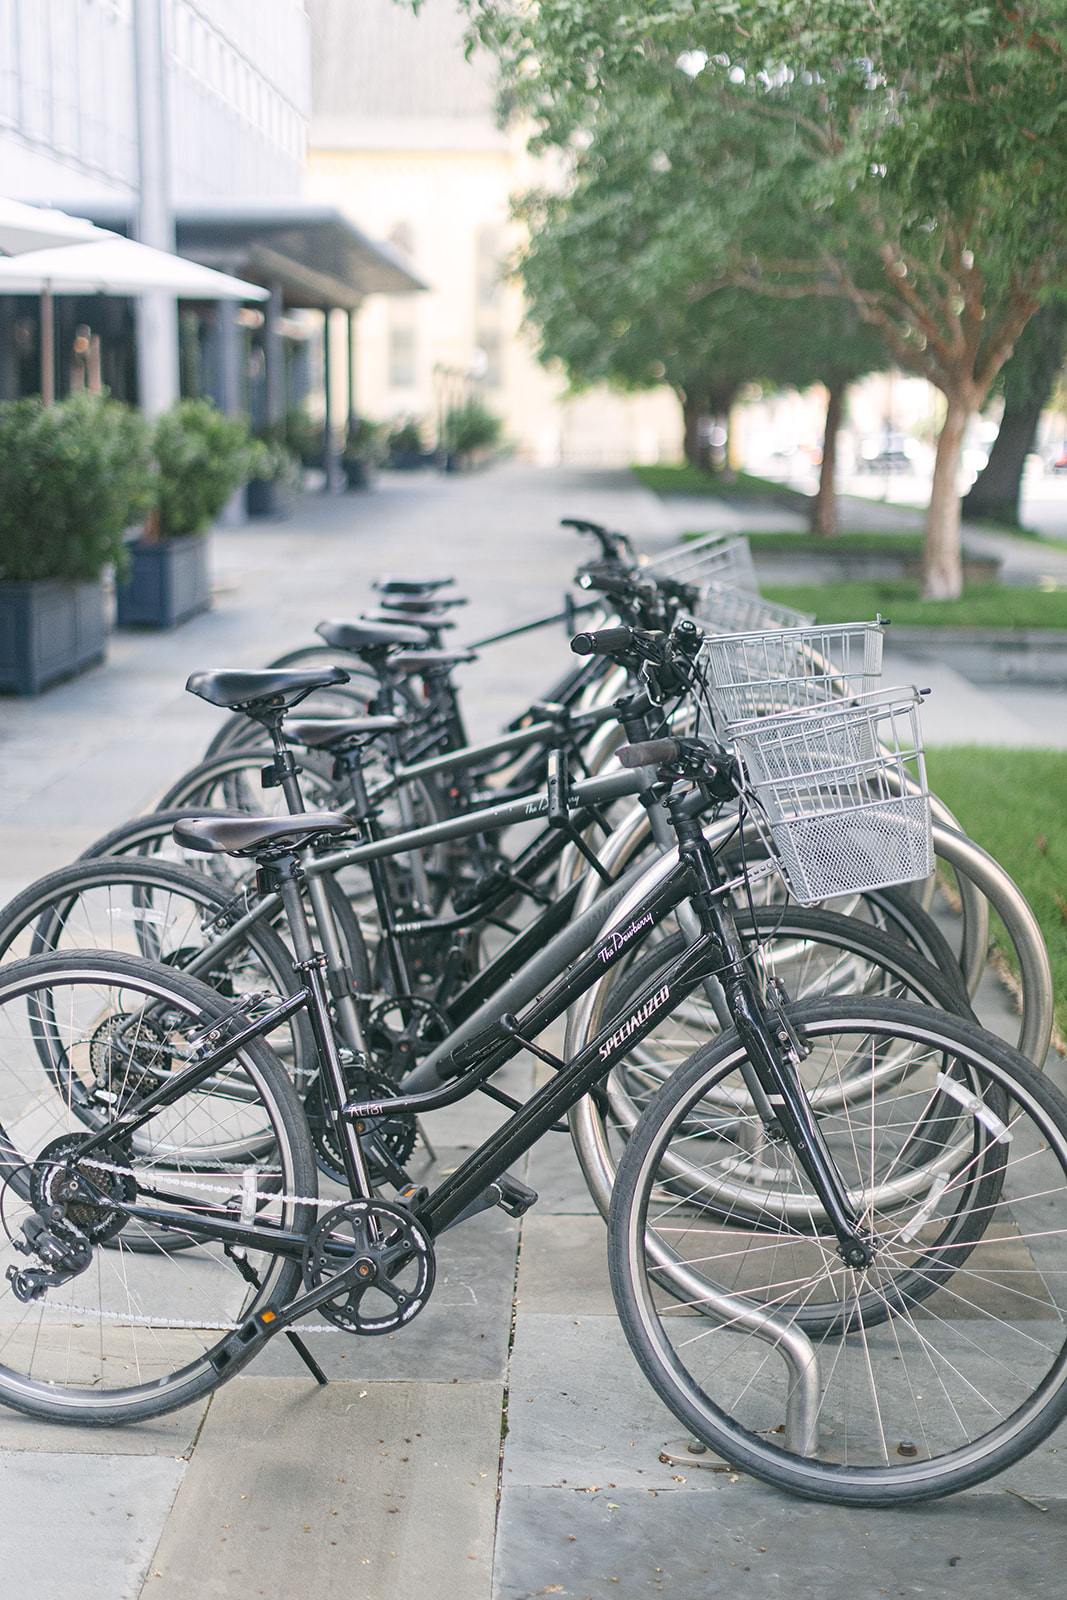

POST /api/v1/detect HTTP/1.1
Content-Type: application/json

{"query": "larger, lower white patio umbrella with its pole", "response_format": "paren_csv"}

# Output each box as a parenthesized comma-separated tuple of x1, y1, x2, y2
(0, 234, 270, 405)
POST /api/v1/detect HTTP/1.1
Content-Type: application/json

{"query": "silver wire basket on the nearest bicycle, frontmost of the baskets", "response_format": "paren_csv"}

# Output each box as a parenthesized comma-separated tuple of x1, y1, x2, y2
(729, 690, 934, 906)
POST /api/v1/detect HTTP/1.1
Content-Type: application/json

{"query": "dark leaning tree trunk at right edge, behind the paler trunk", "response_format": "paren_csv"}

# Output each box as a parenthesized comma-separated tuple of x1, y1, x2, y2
(963, 306, 1067, 528)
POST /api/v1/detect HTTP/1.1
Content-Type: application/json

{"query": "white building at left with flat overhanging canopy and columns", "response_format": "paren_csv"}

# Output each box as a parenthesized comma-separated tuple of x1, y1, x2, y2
(0, 0, 421, 427)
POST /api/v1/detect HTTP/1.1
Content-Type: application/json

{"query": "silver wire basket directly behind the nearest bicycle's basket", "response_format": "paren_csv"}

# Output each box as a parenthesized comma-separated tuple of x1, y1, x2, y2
(702, 621, 883, 722)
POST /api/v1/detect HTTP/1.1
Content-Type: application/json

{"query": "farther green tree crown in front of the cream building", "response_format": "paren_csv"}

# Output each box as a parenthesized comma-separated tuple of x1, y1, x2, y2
(517, 67, 888, 531)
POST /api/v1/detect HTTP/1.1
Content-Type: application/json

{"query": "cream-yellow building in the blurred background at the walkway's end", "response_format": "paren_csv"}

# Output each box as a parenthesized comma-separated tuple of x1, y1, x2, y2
(307, 0, 680, 466)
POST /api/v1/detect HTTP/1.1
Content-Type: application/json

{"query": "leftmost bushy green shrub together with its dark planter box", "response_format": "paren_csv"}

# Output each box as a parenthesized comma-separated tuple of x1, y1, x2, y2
(0, 394, 154, 694)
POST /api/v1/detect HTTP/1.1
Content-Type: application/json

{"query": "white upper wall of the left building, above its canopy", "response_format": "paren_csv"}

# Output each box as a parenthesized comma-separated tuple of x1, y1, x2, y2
(0, 0, 309, 210)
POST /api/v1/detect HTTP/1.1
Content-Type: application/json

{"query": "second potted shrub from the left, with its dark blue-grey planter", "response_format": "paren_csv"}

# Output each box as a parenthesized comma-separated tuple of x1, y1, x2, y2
(117, 400, 254, 627)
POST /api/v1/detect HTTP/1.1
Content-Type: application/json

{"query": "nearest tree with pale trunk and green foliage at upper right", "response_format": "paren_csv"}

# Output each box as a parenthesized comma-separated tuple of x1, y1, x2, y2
(454, 0, 1067, 597)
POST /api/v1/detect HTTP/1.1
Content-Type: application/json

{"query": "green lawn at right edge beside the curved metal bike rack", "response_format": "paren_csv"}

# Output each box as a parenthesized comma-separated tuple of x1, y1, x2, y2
(926, 746, 1067, 1035)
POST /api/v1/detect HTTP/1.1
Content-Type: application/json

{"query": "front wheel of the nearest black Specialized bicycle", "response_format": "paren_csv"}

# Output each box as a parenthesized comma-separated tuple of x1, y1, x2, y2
(609, 1000, 1067, 1506)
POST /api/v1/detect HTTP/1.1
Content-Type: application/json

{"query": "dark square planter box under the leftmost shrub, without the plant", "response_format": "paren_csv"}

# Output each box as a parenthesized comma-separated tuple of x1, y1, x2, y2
(0, 578, 107, 694)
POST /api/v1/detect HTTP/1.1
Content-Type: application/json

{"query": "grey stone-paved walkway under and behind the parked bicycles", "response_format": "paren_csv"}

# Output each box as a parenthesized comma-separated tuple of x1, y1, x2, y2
(0, 466, 1067, 1600)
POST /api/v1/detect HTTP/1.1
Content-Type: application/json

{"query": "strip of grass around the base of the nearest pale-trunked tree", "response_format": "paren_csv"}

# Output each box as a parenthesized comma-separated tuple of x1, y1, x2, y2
(761, 578, 1067, 629)
